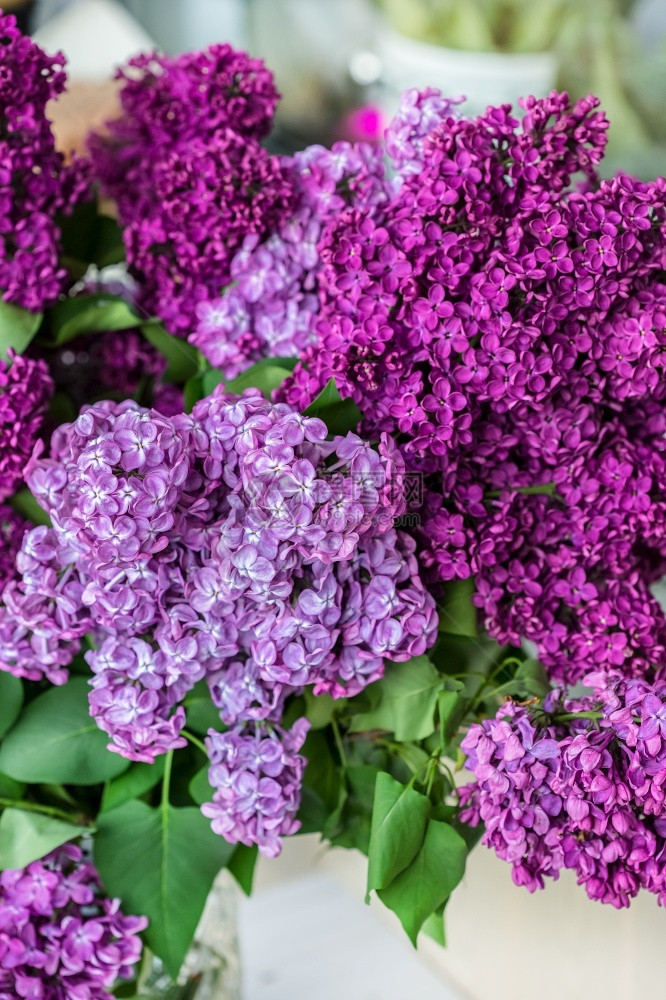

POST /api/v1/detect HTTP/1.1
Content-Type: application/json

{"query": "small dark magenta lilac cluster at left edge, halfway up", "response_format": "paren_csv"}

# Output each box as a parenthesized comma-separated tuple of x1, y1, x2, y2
(0, 351, 53, 501)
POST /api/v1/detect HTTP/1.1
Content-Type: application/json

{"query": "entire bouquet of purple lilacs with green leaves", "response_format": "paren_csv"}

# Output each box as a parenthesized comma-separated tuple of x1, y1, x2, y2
(0, 16, 666, 1000)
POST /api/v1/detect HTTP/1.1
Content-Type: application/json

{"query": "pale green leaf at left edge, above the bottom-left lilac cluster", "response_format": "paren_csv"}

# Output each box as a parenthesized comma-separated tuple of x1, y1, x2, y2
(0, 809, 91, 869)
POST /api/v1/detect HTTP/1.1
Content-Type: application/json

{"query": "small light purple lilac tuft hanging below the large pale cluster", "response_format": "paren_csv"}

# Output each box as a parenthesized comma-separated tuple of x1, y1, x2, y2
(201, 719, 309, 858)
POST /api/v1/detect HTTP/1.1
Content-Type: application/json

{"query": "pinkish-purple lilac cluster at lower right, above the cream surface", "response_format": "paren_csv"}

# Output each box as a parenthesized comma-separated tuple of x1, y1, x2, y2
(459, 680, 666, 908)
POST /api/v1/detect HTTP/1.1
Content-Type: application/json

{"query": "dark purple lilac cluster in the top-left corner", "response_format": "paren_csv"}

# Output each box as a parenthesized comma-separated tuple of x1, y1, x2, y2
(0, 13, 88, 312)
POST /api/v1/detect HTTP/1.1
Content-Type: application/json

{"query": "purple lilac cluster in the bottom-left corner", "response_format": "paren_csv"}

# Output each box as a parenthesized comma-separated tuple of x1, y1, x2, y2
(0, 844, 148, 1000)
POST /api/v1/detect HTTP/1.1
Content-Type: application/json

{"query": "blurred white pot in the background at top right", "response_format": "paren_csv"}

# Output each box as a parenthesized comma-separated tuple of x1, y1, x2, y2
(377, 27, 557, 116)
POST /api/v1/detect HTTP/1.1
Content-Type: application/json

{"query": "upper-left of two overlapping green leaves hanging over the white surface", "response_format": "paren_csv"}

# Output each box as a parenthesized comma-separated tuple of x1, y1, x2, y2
(367, 771, 430, 893)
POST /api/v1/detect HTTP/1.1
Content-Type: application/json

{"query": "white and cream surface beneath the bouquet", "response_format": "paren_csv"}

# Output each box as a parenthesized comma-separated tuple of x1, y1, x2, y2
(240, 836, 666, 1000)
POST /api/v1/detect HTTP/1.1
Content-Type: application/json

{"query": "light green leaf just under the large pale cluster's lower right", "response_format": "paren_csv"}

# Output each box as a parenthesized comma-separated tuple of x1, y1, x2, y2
(350, 656, 443, 741)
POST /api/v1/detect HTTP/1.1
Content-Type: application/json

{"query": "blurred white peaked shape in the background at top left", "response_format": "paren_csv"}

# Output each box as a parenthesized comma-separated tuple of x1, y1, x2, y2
(34, 0, 155, 80)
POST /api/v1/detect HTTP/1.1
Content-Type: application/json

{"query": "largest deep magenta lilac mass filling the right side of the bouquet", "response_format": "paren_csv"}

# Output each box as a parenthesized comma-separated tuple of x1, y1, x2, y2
(284, 92, 666, 680)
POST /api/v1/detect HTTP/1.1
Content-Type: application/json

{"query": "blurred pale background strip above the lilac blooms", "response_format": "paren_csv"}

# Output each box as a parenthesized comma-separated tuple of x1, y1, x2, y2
(13, 0, 666, 178)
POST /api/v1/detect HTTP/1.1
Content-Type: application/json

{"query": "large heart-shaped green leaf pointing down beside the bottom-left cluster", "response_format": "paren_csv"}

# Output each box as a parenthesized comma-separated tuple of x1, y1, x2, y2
(94, 801, 234, 979)
